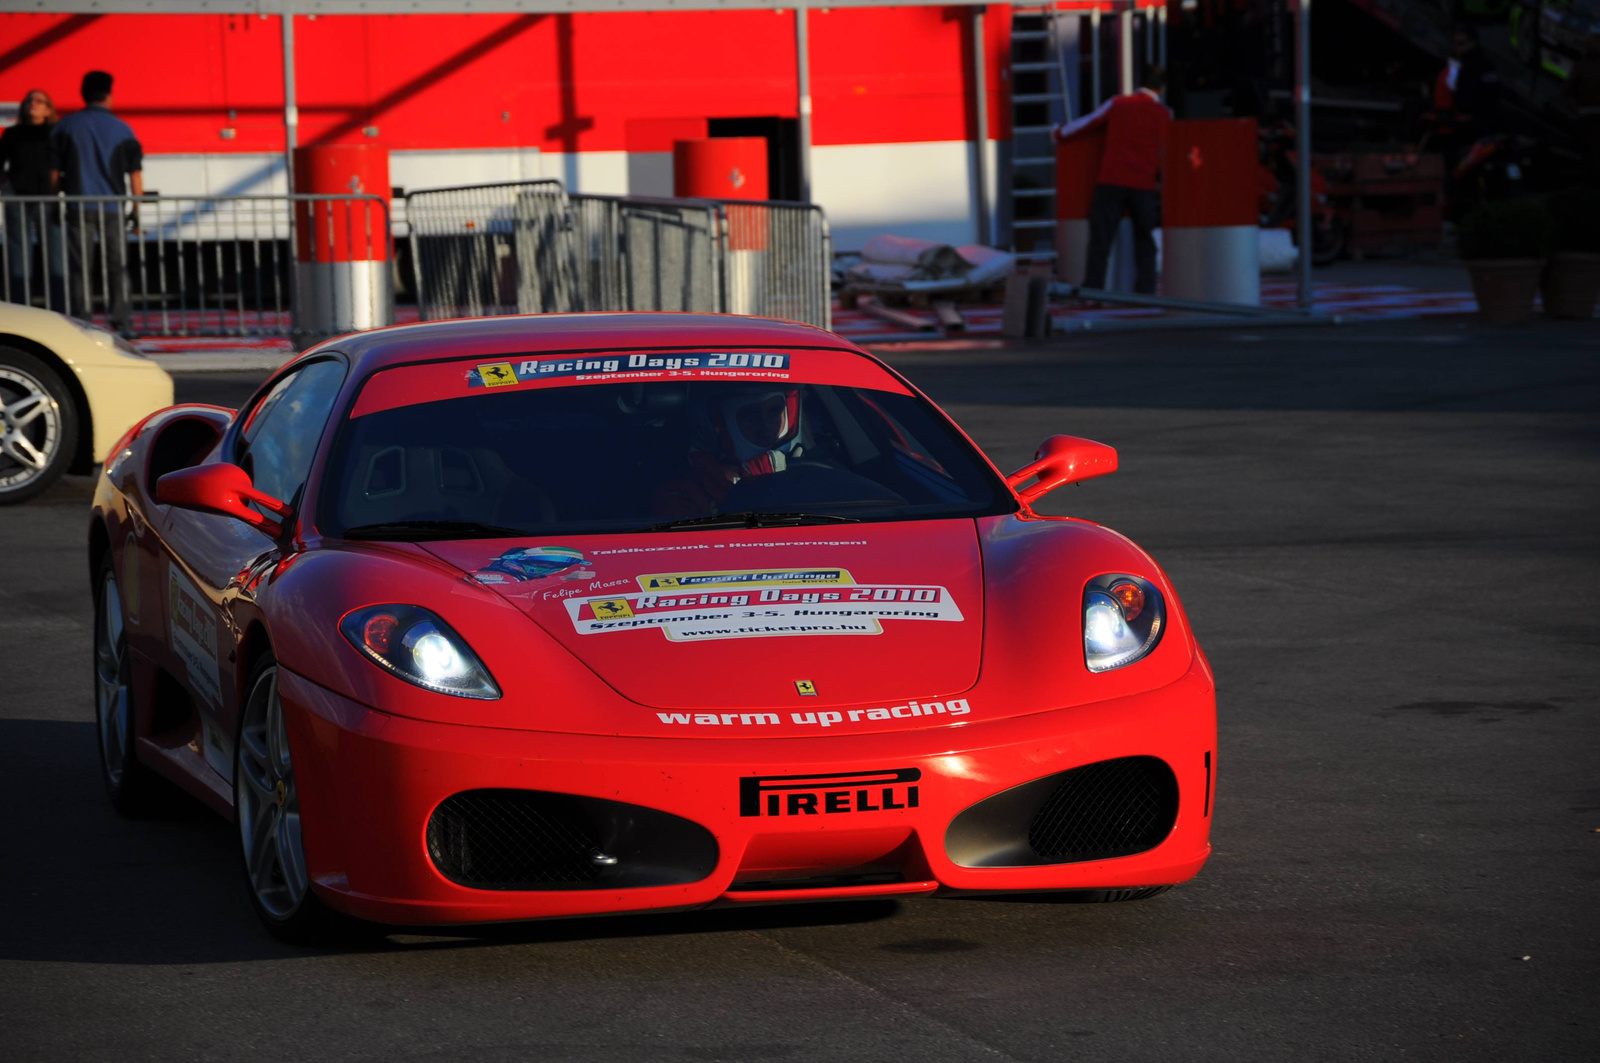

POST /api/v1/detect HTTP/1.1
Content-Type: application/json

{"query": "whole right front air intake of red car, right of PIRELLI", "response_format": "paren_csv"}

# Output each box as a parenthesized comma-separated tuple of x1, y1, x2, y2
(944, 757, 1178, 868)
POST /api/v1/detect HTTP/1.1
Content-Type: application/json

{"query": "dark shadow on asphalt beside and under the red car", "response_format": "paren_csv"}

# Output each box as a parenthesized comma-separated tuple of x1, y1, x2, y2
(0, 720, 899, 965)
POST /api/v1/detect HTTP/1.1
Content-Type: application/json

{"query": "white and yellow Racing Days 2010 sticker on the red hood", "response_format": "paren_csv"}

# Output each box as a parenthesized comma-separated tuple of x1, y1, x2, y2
(563, 568, 963, 642)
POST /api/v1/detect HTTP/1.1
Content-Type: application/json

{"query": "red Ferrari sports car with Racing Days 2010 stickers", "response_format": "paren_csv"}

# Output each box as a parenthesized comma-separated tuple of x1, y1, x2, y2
(90, 314, 1216, 940)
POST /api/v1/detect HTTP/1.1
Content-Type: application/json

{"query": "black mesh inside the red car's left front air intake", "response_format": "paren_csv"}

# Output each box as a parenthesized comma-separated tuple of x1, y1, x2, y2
(427, 789, 600, 890)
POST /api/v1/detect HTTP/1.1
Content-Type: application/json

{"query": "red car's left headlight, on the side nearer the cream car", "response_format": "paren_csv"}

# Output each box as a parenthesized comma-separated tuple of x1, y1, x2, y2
(339, 605, 499, 701)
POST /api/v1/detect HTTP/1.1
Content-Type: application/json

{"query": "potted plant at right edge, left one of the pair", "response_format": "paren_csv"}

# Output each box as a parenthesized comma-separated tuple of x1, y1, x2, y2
(1459, 199, 1550, 325)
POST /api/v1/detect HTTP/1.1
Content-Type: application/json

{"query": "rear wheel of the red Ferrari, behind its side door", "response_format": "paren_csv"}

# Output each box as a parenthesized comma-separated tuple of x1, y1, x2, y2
(94, 551, 165, 816)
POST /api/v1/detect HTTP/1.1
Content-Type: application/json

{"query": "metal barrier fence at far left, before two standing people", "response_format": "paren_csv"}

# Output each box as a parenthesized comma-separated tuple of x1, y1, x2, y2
(0, 195, 394, 336)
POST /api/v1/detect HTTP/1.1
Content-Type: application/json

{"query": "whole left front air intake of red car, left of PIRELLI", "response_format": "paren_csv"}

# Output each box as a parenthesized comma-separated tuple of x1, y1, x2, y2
(427, 789, 717, 890)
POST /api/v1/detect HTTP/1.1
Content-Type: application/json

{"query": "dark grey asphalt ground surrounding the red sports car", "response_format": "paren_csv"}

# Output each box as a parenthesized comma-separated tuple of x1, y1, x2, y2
(0, 320, 1600, 1063)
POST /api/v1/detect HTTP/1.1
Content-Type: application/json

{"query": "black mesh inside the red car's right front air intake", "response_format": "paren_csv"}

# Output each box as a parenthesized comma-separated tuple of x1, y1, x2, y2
(1027, 757, 1178, 863)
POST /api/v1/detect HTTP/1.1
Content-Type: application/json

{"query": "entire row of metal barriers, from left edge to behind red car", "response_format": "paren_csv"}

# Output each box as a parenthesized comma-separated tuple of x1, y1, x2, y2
(0, 181, 832, 339)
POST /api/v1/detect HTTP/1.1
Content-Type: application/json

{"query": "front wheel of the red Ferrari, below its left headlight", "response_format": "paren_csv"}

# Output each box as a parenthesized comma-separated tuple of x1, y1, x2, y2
(234, 653, 365, 945)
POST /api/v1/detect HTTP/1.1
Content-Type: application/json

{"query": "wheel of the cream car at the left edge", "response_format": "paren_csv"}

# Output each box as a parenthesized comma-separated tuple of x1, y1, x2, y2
(0, 346, 78, 506)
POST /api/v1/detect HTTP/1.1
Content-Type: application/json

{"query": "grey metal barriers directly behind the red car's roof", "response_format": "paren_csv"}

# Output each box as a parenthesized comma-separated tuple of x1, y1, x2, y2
(406, 181, 832, 328)
